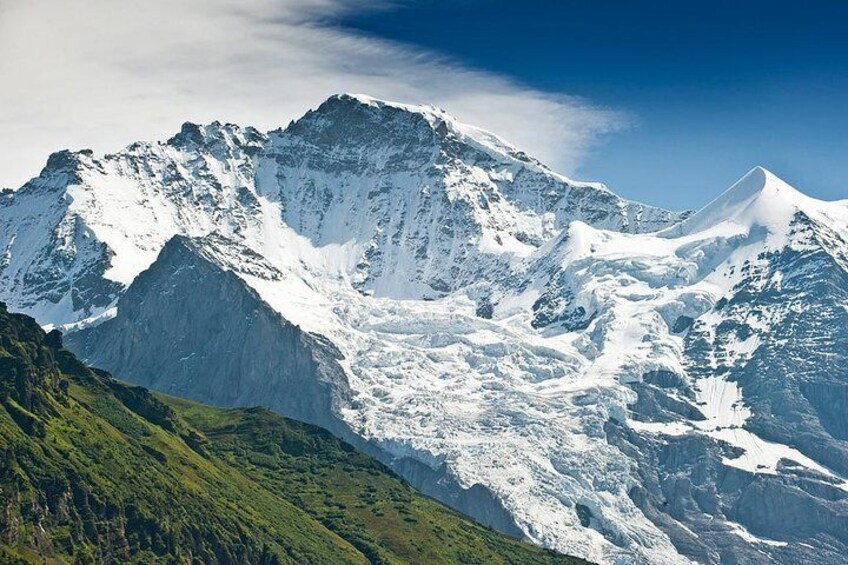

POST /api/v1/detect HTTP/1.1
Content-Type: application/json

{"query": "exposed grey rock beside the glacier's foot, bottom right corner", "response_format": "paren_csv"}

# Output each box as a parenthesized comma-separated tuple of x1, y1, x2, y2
(606, 422, 848, 564)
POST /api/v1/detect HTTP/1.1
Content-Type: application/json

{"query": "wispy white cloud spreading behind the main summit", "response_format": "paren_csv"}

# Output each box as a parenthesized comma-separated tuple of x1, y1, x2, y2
(0, 0, 624, 186)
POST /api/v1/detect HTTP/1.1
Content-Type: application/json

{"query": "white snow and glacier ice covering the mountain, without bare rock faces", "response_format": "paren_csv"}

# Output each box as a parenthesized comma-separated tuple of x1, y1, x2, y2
(3, 97, 848, 563)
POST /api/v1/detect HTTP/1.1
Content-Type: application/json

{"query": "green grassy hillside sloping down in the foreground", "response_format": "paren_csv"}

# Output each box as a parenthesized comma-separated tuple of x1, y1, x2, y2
(0, 305, 578, 564)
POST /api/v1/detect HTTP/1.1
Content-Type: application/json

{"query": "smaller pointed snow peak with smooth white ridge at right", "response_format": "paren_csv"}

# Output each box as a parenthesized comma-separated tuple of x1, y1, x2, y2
(506, 167, 848, 329)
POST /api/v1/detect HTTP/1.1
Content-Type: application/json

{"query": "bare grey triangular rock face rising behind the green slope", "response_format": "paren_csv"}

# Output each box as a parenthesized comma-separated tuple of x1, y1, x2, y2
(65, 237, 349, 432)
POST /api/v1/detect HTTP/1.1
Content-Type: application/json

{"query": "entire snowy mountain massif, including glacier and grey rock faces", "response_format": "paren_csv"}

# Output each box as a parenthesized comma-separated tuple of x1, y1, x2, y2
(0, 95, 848, 563)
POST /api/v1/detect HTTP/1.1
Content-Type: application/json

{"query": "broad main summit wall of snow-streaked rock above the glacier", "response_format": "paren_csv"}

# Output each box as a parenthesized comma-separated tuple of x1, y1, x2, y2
(0, 95, 676, 324)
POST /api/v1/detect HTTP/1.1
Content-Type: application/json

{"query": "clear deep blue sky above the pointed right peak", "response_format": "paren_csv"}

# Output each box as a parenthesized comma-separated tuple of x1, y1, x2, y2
(336, 0, 848, 208)
